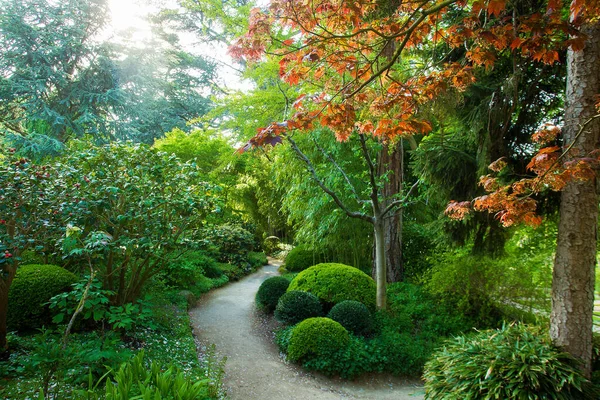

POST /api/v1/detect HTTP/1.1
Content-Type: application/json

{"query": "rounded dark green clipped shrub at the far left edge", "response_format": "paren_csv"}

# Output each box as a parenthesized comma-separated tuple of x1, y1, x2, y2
(7, 264, 77, 330)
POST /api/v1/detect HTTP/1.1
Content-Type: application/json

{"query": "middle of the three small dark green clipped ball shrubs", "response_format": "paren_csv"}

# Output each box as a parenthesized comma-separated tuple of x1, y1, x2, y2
(275, 290, 323, 325)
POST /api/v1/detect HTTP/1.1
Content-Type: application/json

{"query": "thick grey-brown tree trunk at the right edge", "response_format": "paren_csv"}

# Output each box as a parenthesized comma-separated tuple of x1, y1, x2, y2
(550, 22, 600, 378)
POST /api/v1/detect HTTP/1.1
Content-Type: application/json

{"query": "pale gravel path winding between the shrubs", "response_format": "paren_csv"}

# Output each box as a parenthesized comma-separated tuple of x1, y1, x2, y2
(190, 260, 423, 400)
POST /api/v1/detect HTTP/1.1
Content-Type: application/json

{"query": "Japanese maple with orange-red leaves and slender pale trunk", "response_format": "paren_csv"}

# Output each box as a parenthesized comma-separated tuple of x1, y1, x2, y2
(231, 0, 600, 375)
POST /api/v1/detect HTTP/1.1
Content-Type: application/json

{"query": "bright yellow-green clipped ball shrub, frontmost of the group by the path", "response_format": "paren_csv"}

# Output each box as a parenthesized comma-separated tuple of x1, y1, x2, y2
(287, 318, 350, 361)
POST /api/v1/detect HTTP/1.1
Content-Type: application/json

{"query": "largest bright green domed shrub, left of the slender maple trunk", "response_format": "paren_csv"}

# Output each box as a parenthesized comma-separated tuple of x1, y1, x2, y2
(288, 263, 376, 311)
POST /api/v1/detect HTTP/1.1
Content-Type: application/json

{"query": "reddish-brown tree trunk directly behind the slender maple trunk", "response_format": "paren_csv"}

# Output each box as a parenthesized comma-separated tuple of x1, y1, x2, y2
(372, 141, 404, 283)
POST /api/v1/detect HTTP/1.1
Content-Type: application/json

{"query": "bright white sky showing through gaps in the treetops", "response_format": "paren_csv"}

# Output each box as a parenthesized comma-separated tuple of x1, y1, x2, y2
(109, 0, 252, 91)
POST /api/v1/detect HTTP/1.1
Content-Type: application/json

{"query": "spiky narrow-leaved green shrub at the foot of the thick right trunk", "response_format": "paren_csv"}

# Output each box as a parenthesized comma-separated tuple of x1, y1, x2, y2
(423, 324, 585, 400)
